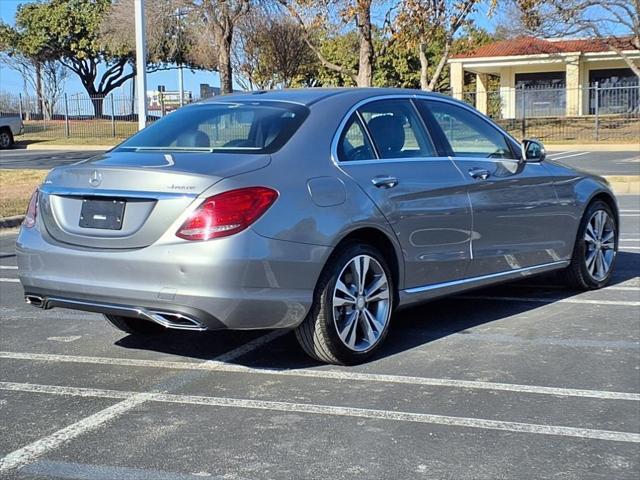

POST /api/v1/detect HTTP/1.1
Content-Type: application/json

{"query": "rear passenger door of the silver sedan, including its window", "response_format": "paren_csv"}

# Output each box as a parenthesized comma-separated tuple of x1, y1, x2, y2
(334, 98, 471, 288)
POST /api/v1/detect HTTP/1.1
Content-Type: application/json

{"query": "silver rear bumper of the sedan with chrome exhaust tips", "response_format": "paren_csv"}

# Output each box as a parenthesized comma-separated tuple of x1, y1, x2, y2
(16, 228, 329, 330)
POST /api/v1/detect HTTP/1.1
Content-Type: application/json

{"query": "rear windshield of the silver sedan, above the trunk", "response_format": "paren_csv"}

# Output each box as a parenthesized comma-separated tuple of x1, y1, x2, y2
(117, 102, 309, 153)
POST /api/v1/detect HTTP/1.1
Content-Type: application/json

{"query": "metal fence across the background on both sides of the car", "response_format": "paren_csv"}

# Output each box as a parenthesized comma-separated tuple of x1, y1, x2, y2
(0, 84, 640, 142)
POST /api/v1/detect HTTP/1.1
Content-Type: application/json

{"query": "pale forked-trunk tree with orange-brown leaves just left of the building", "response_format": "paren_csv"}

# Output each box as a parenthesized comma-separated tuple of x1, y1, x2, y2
(394, 0, 496, 90)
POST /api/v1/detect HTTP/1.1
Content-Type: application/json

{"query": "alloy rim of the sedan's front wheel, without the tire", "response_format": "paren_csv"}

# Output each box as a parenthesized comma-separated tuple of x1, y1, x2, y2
(584, 210, 616, 282)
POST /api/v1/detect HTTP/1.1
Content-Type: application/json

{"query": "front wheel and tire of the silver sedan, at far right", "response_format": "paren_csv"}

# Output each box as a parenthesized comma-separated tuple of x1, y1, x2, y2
(564, 200, 618, 290)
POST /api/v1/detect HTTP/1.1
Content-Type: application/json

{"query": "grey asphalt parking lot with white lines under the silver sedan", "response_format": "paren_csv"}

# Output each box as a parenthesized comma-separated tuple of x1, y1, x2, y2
(0, 203, 640, 480)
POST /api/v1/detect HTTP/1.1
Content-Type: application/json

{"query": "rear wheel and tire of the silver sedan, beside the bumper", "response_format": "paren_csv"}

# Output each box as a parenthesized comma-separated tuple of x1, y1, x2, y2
(295, 244, 395, 365)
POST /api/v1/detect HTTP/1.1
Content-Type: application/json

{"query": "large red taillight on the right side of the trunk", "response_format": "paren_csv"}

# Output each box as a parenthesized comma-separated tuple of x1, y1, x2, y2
(176, 187, 278, 240)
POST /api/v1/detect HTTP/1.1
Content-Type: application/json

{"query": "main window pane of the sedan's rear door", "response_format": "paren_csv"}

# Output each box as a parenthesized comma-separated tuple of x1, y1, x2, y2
(358, 100, 435, 158)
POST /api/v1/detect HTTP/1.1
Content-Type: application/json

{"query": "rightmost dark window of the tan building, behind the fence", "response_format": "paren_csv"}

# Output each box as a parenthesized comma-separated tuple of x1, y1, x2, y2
(589, 68, 640, 115)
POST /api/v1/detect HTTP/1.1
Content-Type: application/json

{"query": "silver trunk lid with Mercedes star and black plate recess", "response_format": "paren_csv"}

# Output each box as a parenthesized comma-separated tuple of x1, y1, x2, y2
(39, 150, 270, 249)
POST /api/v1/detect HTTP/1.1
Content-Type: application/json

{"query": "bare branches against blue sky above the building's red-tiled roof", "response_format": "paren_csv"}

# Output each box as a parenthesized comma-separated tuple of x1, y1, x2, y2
(514, 0, 640, 77)
